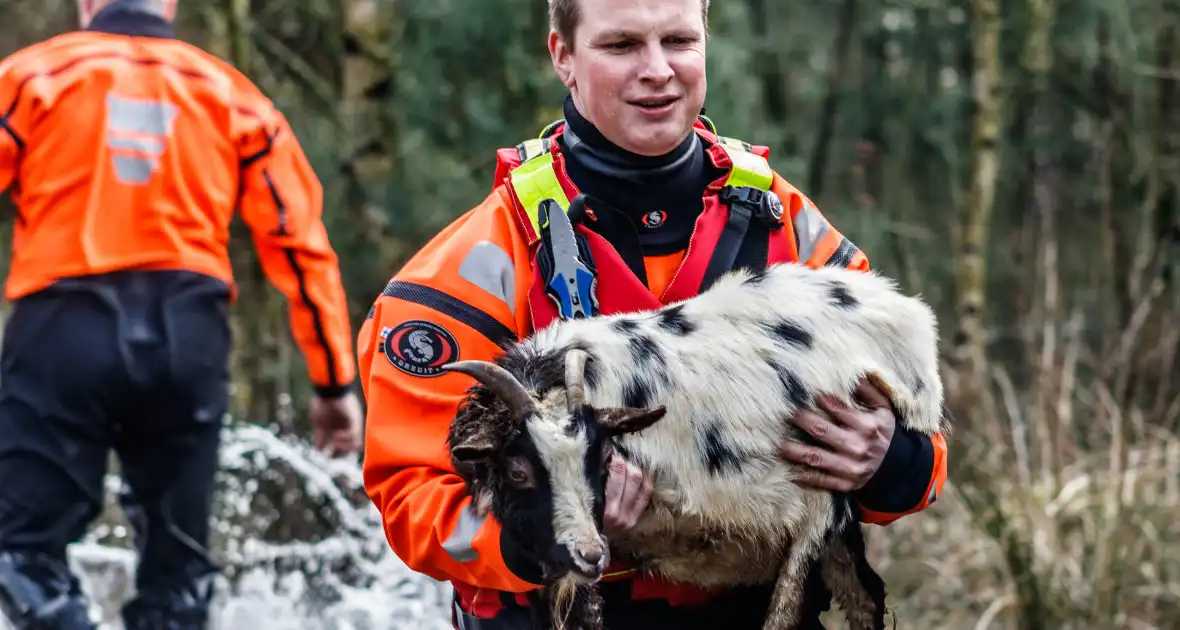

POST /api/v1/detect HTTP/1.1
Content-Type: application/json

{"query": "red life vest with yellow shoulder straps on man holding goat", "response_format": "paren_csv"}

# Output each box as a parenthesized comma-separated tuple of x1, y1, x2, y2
(479, 117, 798, 605)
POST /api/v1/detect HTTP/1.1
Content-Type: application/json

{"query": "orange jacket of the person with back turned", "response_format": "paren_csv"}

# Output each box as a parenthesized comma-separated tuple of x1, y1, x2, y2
(0, 31, 355, 395)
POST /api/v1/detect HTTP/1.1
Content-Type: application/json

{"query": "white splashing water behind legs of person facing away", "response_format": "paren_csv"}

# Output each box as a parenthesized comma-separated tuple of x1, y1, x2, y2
(0, 426, 451, 630)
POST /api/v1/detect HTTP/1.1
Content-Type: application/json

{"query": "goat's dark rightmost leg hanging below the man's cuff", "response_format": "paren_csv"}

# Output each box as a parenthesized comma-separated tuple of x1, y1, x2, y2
(820, 523, 885, 630)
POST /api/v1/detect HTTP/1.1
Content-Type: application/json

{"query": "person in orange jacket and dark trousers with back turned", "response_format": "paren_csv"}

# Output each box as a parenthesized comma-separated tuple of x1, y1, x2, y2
(0, 0, 362, 630)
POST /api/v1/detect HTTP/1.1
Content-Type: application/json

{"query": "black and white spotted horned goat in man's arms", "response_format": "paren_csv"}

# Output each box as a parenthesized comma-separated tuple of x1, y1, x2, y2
(448, 264, 950, 629)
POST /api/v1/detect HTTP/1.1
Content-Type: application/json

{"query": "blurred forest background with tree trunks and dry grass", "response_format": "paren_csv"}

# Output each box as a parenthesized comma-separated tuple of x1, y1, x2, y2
(0, 0, 1180, 630)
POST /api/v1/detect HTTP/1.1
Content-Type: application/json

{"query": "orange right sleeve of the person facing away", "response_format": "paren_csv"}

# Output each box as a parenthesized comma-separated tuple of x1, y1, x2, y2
(235, 94, 356, 396)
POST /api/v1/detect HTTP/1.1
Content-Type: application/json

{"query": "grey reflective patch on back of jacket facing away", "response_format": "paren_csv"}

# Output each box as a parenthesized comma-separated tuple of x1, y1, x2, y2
(106, 94, 178, 184)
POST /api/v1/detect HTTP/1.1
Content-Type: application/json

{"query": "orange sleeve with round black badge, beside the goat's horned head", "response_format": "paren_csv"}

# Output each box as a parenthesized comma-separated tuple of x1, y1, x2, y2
(358, 191, 537, 592)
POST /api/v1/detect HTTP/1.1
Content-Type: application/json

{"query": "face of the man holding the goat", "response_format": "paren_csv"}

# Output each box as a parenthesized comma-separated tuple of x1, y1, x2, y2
(549, 0, 706, 156)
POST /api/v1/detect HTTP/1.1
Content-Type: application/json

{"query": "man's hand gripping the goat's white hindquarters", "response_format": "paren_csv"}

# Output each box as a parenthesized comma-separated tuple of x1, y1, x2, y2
(781, 379, 897, 492)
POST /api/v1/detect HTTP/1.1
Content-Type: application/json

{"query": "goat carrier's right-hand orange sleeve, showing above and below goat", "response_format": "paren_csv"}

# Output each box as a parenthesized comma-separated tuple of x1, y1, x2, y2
(774, 175, 948, 525)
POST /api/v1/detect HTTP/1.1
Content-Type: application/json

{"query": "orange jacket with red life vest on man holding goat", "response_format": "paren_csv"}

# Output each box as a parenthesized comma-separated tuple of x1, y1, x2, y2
(358, 119, 946, 617)
